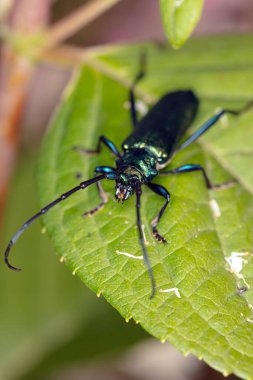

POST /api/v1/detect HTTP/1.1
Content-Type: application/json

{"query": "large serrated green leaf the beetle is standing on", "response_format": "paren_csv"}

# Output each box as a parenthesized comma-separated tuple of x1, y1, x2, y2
(38, 37, 253, 379)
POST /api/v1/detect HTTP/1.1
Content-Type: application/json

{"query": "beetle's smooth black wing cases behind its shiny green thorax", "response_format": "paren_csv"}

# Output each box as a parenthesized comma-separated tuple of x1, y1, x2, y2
(122, 91, 199, 164)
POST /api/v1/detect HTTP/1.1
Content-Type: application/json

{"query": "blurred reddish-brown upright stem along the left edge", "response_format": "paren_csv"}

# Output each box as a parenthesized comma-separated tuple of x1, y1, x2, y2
(0, 0, 52, 225)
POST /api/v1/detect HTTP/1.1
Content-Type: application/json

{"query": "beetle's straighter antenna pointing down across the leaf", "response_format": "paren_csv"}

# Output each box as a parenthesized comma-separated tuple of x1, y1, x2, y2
(136, 185, 156, 299)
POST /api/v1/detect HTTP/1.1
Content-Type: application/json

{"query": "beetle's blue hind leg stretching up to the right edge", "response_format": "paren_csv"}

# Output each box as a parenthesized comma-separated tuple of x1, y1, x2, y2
(176, 101, 253, 152)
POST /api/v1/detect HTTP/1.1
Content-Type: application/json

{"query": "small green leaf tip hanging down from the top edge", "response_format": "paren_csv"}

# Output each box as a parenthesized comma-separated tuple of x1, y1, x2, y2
(160, 0, 203, 48)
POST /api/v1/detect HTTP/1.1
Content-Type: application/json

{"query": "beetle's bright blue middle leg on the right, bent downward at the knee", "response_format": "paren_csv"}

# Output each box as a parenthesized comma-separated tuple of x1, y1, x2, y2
(159, 164, 236, 190)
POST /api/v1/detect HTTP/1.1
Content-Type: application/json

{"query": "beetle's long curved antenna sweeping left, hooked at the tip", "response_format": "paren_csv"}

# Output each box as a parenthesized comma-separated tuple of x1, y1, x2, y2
(4, 174, 107, 271)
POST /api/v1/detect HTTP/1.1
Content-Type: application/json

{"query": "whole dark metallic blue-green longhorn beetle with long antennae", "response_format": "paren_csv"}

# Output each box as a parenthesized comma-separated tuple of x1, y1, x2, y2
(5, 55, 253, 298)
